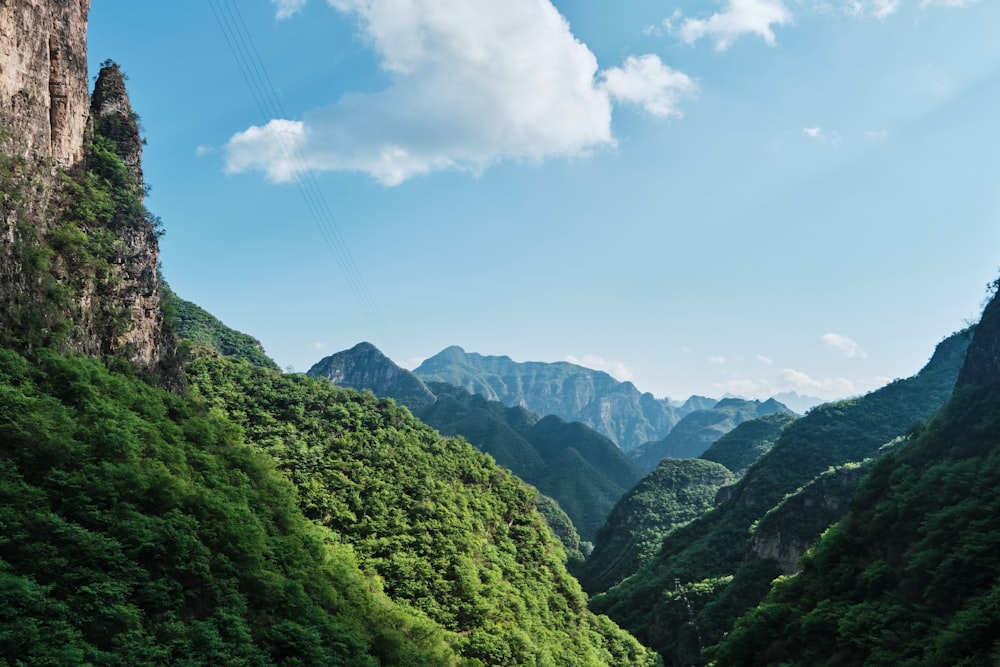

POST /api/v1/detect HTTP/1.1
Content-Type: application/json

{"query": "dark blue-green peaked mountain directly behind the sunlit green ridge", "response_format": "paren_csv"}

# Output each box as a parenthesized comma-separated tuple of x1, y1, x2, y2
(307, 343, 641, 542)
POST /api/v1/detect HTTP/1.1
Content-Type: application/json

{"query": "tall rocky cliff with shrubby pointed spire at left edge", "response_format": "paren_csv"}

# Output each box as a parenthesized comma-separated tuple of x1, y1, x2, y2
(0, 0, 173, 380)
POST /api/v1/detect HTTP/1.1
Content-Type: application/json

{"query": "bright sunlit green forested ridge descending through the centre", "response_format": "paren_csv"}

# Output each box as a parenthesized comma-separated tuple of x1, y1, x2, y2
(189, 358, 653, 665)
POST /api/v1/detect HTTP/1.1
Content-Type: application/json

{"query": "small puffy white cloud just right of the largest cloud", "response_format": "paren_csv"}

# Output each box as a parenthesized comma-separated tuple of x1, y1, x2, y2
(601, 55, 698, 118)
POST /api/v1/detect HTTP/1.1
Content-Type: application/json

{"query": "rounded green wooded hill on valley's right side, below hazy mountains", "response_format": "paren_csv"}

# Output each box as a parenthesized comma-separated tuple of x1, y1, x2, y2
(576, 459, 733, 594)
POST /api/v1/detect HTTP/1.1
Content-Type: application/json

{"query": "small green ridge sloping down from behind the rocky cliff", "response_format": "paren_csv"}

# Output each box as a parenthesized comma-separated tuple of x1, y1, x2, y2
(162, 285, 280, 370)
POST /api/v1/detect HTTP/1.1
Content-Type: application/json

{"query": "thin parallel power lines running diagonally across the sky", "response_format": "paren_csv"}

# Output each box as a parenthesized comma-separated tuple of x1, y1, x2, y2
(208, 0, 397, 358)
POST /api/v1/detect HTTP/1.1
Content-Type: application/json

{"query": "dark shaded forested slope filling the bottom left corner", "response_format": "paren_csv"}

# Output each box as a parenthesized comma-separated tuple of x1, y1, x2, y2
(0, 350, 458, 667)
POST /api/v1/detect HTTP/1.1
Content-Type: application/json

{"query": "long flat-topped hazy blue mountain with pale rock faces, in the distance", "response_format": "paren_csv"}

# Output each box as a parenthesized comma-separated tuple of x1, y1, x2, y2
(413, 346, 714, 451)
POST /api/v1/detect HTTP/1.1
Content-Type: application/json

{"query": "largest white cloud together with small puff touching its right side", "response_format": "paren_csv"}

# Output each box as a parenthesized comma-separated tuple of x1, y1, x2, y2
(226, 0, 694, 186)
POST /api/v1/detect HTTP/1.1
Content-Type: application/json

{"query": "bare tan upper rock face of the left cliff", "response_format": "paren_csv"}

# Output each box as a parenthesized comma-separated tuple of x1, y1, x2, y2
(0, 0, 90, 166)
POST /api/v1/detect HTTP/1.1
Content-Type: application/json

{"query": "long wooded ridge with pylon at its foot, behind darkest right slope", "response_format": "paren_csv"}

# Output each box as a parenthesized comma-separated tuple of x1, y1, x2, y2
(591, 331, 969, 662)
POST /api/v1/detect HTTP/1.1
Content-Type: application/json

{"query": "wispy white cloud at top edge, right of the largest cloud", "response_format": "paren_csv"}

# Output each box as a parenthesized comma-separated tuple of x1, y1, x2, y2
(676, 0, 792, 51)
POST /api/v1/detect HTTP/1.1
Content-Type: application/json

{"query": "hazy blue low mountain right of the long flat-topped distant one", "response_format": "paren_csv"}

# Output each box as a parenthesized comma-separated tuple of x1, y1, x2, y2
(629, 398, 792, 470)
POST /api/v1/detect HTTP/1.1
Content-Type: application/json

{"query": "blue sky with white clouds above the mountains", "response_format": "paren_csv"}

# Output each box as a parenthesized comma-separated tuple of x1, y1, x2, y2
(89, 0, 1000, 399)
